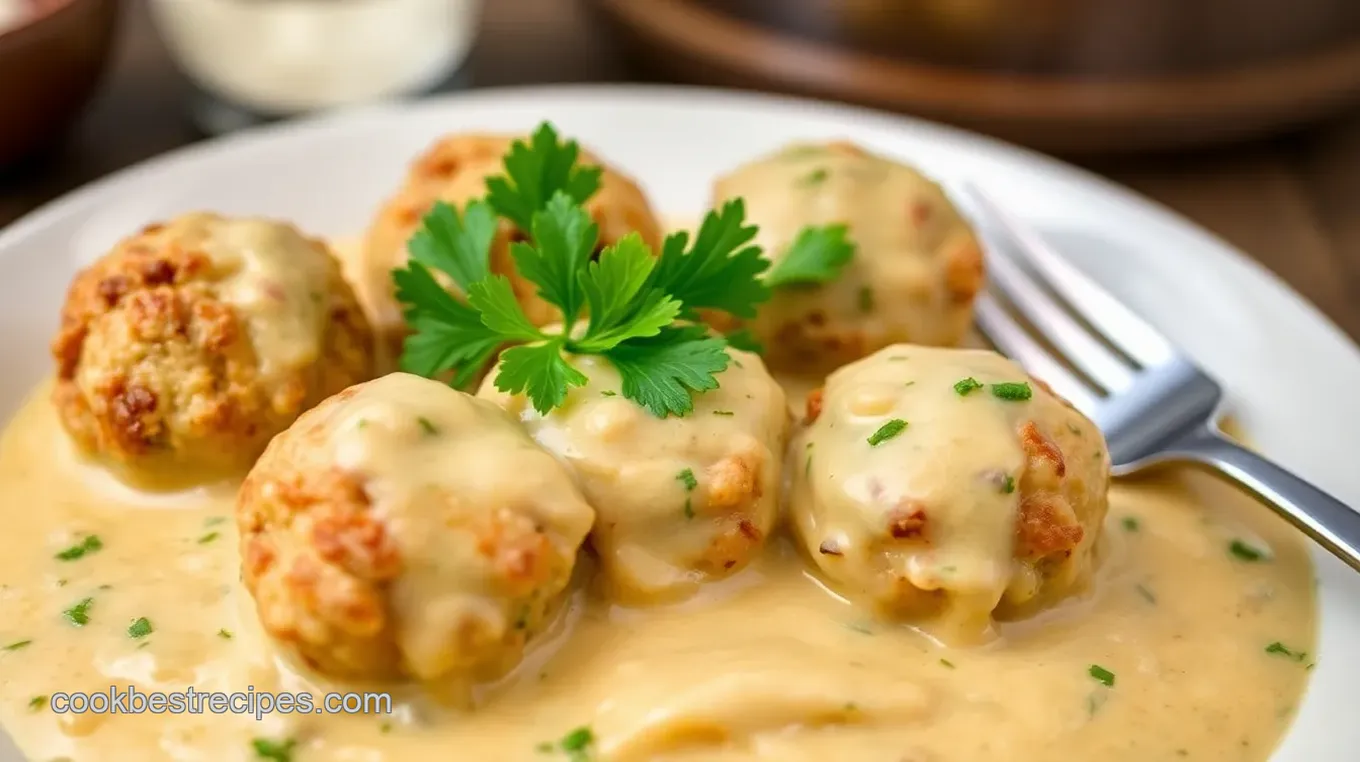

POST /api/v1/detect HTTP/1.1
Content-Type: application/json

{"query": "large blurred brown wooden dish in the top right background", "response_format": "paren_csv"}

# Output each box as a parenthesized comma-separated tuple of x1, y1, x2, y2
(594, 0, 1360, 154)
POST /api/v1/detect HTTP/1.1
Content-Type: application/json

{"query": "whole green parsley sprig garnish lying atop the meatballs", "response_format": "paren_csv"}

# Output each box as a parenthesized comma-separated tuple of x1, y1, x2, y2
(392, 124, 849, 418)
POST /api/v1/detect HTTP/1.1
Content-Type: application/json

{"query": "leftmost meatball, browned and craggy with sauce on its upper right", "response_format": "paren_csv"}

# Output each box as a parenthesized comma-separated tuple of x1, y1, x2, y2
(52, 214, 373, 480)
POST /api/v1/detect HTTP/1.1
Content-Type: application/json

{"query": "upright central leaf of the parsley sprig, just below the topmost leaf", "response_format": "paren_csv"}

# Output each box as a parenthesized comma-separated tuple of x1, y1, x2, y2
(510, 192, 600, 327)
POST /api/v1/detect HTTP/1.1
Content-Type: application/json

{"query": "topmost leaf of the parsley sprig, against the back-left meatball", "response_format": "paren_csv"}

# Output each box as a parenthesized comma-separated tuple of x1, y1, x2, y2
(487, 122, 602, 231)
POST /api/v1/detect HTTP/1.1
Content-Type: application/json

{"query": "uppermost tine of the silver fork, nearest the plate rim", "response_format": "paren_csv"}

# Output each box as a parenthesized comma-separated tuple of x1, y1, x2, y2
(967, 182, 1176, 367)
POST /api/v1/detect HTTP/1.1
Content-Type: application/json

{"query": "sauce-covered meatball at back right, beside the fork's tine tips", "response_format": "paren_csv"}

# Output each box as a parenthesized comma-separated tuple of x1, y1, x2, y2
(714, 143, 982, 370)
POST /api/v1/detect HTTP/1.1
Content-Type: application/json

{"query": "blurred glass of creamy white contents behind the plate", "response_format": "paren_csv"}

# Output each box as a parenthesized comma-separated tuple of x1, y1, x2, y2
(151, 0, 481, 132)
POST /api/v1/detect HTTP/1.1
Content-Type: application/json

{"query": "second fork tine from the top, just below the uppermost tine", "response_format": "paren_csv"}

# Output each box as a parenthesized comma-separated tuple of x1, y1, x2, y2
(987, 240, 1133, 393)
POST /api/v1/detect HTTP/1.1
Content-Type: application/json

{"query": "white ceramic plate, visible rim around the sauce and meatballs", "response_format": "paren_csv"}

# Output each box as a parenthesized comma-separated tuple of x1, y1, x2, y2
(0, 87, 1360, 762)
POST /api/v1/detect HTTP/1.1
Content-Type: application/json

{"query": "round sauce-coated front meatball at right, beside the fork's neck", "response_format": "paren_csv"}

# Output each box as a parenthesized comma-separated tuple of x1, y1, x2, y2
(789, 344, 1110, 641)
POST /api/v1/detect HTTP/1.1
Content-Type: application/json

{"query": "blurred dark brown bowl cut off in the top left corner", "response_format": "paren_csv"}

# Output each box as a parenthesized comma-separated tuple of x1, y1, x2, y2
(0, 0, 118, 167)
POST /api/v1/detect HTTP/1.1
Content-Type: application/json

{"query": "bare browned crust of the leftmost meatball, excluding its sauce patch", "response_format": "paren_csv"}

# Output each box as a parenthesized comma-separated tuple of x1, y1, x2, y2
(52, 215, 373, 471)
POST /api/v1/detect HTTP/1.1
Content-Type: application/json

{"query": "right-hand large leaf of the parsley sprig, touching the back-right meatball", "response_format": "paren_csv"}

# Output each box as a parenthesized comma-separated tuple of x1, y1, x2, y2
(649, 199, 770, 317)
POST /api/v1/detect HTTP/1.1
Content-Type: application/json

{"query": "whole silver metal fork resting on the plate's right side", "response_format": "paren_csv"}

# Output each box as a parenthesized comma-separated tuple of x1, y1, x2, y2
(968, 186, 1360, 572)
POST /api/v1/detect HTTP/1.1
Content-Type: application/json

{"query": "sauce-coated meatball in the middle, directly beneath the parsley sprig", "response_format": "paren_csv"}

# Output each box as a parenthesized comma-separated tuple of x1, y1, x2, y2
(479, 350, 789, 603)
